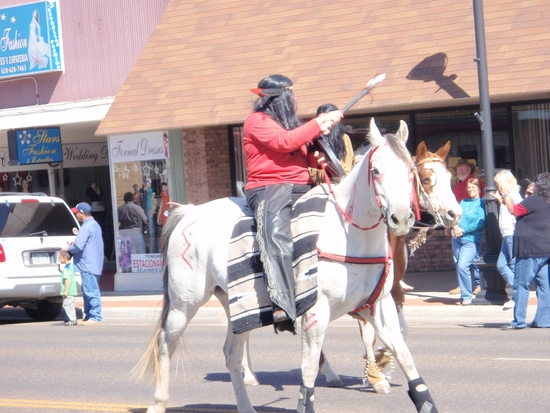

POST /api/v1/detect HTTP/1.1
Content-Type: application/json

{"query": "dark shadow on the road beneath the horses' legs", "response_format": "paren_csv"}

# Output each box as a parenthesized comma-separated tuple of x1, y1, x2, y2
(204, 369, 401, 393)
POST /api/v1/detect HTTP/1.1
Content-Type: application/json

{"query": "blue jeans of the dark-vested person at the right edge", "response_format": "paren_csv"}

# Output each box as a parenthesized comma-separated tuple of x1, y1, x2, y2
(510, 257, 550, 328)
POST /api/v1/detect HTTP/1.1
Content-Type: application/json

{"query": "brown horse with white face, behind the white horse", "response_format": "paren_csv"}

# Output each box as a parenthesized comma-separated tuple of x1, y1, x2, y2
(243, 142, 462, 394)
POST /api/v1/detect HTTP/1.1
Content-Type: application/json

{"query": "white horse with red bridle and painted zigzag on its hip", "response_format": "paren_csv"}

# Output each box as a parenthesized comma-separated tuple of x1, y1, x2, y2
(136, 121, 437, 413)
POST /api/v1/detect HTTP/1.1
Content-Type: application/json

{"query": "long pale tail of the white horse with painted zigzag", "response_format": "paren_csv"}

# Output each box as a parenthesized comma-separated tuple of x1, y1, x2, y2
(131, 204, 194, 379)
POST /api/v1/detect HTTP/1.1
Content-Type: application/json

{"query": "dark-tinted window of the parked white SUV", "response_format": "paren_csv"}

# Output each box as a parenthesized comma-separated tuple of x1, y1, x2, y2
(0, 202, 77, 238)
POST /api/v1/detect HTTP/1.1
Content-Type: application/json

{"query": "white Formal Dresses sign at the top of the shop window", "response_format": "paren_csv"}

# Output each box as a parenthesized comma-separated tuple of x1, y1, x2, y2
(109, 132, 168, 162)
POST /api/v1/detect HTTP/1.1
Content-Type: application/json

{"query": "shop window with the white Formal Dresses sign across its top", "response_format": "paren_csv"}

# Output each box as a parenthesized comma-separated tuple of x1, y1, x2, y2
(109, 131, 170, 273)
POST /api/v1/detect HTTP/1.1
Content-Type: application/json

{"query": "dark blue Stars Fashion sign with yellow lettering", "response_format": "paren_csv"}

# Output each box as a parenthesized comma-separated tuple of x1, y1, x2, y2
(8, 128, 63, 165)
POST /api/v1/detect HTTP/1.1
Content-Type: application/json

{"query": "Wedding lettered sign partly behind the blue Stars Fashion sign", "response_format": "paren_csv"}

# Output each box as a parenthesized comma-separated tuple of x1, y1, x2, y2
(0, 142, 109, 168)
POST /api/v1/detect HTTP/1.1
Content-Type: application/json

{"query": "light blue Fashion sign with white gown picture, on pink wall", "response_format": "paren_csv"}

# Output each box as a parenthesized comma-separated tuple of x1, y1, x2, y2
(0, 1, 63, 79)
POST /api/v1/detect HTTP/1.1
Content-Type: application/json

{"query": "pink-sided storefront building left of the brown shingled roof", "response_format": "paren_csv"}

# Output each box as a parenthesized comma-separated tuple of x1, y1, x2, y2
(0, 0, 169, 286)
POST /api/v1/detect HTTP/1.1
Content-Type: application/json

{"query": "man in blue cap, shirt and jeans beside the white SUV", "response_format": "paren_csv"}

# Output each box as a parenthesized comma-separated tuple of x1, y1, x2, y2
(65, 202, 104, 325)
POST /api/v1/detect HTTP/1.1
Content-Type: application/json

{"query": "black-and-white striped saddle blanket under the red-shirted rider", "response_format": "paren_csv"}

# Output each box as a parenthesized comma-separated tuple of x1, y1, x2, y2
(227, 185, 328, 333)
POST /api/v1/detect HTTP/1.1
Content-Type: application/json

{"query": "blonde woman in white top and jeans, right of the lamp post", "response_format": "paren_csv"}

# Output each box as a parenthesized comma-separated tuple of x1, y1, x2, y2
(492, 170, 523, 310)
